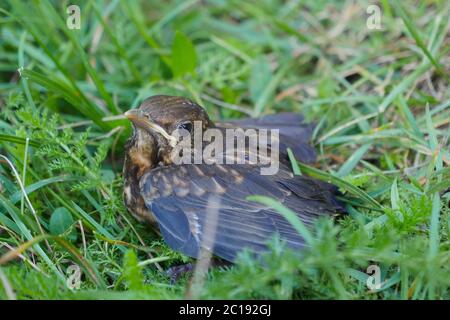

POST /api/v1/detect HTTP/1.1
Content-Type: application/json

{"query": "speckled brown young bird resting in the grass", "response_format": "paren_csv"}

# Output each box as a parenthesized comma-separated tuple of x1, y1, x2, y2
(123, 95, 344, 262)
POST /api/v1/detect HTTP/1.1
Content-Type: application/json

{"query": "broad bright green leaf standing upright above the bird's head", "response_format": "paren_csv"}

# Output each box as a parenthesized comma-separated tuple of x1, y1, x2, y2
(172, 32, 197, 77)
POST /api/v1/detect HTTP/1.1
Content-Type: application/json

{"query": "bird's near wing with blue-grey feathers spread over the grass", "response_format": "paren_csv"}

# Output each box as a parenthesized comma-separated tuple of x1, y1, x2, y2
(140, 164, 340, 261)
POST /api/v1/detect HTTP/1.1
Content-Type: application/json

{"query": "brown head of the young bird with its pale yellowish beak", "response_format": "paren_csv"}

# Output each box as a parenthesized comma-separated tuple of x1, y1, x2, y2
(125, 95, 214, 168)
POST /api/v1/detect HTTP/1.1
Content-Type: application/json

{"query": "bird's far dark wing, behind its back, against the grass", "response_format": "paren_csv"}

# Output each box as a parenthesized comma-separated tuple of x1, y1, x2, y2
(216, 112, 316, 163)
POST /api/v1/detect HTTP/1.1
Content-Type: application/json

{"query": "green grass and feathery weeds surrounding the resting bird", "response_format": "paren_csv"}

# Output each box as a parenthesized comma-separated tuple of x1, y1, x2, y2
(0, 0, 450, 299)
